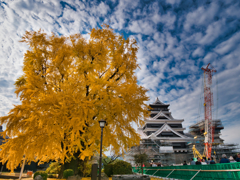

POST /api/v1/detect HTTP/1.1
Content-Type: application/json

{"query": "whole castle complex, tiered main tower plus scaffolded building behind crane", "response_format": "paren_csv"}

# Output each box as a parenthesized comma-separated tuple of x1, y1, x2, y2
(124, 98, 239, 165)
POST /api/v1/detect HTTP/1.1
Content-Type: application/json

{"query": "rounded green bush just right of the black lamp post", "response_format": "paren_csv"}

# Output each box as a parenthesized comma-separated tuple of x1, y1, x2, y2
(113, 161, 132, 174)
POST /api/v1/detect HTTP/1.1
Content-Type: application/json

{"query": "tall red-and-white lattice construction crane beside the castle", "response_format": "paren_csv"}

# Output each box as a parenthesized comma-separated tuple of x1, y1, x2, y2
(201, 63, 217, 158)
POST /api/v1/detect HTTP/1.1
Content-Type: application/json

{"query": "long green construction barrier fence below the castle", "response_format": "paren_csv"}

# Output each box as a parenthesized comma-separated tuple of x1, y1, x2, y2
(133, 162, 240, 180)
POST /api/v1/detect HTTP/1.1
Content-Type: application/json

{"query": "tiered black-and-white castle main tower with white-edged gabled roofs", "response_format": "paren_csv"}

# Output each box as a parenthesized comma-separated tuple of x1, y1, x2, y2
(137, 98, 192, 165)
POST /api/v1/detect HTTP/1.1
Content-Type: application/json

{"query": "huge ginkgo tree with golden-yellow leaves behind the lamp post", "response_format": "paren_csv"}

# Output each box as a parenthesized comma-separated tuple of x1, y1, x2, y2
(0, 25, 148, 174)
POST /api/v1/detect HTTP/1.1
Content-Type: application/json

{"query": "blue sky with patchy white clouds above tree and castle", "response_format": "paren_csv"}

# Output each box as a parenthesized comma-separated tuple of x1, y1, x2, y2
(0, 0, 240, 143)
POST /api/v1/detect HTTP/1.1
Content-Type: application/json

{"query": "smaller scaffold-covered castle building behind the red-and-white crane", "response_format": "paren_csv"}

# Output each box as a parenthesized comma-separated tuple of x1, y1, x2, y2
(188, 119, 239, 161)
